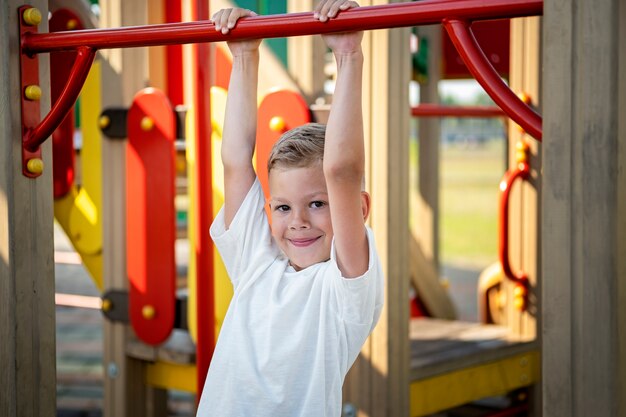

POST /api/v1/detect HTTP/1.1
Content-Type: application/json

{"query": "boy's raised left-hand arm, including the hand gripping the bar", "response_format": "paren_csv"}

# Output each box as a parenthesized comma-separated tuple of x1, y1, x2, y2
(211, 8, 260, 229)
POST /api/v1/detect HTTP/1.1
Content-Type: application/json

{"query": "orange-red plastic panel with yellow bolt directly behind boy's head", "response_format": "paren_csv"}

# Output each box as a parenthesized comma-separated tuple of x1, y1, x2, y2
(256, 90, 311, 202)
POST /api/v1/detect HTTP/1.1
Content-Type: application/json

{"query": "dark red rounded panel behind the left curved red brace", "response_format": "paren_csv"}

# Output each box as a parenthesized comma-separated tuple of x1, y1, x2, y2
(48, 9, 84, 198)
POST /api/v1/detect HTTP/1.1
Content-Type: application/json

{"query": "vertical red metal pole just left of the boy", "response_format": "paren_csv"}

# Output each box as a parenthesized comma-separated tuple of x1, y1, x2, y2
(193, 0, 216, 401)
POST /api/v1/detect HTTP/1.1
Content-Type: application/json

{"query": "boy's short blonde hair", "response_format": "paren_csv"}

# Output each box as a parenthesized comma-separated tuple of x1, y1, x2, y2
(267, 123, 326, 172)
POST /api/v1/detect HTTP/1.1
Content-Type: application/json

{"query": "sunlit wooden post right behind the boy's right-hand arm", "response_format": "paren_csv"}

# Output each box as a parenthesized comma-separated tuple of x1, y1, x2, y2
(344, 1, 410, 417)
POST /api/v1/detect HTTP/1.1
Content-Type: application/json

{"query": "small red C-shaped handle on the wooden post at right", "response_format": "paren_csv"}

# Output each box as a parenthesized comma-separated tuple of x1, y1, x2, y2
(498, 162, 530, 286)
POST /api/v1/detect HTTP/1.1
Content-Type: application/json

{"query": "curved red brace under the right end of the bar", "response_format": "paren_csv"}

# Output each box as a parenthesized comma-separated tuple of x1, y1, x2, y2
(443, 19, 542, 141)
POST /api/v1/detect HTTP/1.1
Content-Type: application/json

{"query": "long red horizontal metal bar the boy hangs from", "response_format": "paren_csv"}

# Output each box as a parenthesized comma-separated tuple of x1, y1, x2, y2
(22, 0, 543, 54)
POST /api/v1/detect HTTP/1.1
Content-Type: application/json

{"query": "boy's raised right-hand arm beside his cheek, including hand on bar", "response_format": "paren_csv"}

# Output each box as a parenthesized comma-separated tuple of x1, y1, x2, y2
(315, 0, 369, 278)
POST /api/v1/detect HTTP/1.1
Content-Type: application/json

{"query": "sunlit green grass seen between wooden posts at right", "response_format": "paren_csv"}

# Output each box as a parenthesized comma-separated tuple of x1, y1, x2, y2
(411, 136, 505, 267)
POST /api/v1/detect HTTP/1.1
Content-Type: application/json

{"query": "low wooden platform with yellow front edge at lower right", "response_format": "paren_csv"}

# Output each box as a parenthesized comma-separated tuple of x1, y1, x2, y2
(409, 319, 540, 417)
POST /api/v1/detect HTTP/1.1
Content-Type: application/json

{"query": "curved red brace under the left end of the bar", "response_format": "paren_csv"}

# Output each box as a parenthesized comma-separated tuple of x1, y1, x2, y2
(24, 46, 96, 152)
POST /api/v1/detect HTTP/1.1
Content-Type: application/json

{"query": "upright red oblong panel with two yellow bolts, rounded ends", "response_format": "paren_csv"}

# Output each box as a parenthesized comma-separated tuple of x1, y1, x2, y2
(126, 88, 176, 345)
